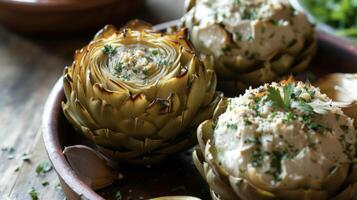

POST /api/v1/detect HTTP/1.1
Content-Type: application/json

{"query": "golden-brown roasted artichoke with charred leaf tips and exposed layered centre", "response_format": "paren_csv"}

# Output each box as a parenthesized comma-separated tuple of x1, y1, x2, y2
(62, 21, 221, 164)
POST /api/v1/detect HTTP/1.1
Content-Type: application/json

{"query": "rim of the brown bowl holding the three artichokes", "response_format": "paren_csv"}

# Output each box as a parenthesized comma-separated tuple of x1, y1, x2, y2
(42, 20, 357, 200)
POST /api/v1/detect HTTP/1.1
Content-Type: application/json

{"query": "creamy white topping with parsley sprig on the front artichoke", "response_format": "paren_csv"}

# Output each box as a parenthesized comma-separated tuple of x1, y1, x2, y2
(213, 82, 356, 189)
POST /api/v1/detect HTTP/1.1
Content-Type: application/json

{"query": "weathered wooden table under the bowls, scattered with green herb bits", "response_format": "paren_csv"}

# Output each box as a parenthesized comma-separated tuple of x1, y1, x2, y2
(0, 0, 183, 200)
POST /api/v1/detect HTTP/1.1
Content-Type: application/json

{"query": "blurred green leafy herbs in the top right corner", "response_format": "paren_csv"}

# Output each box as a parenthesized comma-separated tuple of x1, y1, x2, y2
(301, 0, 357, 38)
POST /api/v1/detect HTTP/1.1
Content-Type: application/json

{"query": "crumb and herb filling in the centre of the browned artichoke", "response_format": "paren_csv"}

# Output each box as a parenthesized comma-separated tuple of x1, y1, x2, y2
(108, 44, 168, 84)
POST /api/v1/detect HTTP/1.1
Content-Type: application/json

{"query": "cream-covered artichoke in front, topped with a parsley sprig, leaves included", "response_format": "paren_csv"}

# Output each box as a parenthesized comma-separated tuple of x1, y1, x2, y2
(193, 82, 357, 200)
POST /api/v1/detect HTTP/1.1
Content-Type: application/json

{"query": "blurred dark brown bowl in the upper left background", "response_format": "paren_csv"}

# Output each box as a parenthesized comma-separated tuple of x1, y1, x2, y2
(0, 0, 143, 33)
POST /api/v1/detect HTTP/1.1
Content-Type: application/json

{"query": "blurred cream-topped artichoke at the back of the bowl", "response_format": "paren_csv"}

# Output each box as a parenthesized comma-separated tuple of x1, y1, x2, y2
(181, 0, 317, 95)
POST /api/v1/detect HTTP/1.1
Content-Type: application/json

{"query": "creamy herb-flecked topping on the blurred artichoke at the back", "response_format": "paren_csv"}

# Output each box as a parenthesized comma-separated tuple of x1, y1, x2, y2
(183, 0, 313, 59)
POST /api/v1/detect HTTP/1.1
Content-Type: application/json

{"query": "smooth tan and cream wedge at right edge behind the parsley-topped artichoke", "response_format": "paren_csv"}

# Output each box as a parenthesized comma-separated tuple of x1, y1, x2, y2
(314, 73, 357, 127)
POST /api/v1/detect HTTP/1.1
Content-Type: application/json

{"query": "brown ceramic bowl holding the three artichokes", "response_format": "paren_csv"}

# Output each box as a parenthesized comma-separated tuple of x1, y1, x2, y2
(43, 21, 357, 200)
